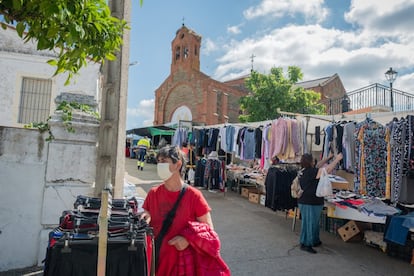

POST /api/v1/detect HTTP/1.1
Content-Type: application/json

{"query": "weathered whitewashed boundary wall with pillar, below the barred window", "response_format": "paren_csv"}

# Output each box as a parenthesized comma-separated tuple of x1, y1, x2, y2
(0, 113, 99, 271)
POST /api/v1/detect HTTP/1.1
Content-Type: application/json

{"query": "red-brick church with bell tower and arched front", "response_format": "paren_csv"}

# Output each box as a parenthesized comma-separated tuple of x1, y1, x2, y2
(153, 24, 345, 125)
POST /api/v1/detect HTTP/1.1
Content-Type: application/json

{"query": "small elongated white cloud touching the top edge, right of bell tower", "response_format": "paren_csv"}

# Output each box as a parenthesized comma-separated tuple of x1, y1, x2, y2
(244, 0, 328, 22)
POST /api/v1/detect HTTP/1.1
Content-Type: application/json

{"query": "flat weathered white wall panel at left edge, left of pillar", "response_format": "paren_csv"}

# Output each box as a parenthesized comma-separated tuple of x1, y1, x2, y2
(0, 127, 48, 271)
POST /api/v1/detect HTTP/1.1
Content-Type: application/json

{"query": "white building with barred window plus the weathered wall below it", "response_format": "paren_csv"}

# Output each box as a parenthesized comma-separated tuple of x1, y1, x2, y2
(0, 24, 101, 272)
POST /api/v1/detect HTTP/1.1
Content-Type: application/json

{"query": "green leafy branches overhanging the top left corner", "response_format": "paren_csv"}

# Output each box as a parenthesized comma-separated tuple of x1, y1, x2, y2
(0, 0, 142, 84)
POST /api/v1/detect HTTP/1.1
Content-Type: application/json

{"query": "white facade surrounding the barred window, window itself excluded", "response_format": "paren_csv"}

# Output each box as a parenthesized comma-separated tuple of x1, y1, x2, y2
(0, 28, 100, 127)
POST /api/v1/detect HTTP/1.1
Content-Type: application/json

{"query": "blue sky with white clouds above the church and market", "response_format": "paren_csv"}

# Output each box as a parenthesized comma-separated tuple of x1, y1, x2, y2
(126, 0, 414, 130)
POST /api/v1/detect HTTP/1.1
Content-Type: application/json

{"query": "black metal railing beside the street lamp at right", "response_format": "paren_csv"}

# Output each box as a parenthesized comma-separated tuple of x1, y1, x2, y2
(321, 83, 414, 115)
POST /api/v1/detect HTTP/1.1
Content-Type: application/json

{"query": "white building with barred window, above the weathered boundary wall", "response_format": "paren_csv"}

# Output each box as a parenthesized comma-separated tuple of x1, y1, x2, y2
(0, 27, 100, 127)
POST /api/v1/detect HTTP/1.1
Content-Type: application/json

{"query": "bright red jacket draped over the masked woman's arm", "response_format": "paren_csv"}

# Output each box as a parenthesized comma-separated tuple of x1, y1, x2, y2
(177, 221, 231, 276)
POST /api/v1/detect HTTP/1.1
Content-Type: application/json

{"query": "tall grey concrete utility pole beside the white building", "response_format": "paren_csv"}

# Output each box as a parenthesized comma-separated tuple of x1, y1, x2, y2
(95, 0, 131, 198)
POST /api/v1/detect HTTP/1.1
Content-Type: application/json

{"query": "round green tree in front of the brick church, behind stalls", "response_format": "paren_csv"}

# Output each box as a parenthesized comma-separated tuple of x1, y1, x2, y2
(239, 66, 324, 122)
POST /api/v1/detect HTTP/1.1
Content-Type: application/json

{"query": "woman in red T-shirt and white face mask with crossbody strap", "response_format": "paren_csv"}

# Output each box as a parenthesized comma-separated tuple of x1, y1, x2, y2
(141, 145, 230, 276)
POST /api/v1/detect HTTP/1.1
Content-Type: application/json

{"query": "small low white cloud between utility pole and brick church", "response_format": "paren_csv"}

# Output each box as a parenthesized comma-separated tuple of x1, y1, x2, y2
(127, 99, 155, 130)
